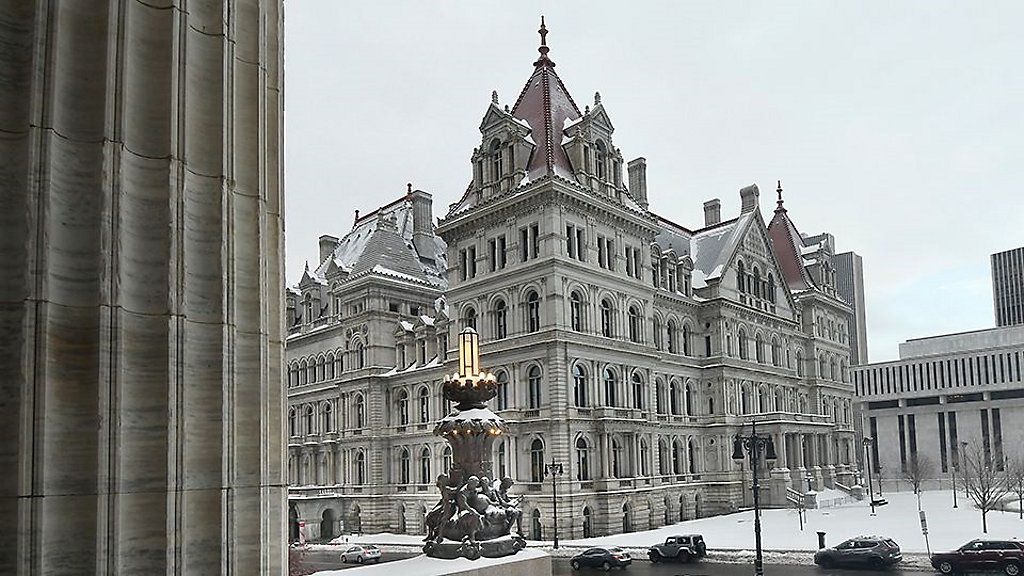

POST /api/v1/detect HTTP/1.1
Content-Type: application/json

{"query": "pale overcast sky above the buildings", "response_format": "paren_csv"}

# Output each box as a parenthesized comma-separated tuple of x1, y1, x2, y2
(285, 0, 1024, 362)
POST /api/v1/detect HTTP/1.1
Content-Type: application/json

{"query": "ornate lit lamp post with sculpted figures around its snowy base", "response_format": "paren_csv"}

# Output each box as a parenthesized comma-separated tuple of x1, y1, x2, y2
(423, 328, 526, 560)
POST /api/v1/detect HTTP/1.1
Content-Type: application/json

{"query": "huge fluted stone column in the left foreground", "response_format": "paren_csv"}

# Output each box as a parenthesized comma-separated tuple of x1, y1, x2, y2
(0, 0, 287, 575)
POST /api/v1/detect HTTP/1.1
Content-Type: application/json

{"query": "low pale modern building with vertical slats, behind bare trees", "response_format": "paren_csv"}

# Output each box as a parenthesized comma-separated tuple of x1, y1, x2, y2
(853, 326, 1024, 481)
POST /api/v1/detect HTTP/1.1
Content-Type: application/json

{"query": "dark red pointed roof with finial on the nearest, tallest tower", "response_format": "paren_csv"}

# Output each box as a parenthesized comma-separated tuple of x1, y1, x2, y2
(512, 16, 583, 180)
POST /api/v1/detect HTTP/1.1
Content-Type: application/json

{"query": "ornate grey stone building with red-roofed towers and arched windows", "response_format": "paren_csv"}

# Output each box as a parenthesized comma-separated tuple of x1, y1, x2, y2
(286, 27, 856, 538)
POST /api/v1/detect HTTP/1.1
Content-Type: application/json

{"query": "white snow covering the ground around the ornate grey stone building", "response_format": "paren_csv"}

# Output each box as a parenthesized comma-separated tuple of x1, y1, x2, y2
(309, 490, 1024, 566)
